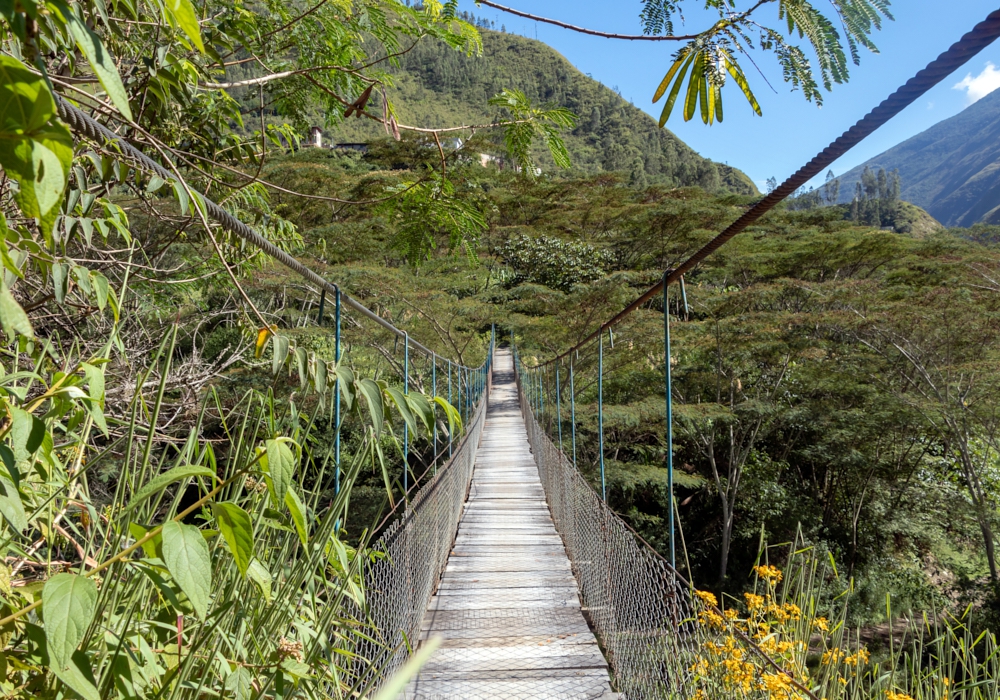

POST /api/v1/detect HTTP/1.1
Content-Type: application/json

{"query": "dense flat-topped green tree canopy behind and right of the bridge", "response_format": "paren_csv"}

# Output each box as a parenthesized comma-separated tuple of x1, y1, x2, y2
(258, 144, 1000, 620)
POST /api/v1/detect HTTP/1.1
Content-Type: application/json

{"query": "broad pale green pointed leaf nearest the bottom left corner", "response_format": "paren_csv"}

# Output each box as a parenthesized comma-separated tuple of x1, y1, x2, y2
(42, 574, 100, 700)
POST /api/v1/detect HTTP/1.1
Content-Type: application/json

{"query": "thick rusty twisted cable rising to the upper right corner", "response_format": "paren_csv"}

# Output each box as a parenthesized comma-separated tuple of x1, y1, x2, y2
(537, 10, 1000, 367)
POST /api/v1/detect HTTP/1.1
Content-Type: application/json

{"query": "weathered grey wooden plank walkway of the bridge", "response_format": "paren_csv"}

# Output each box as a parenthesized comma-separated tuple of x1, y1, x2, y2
(404, 351, 616, 700)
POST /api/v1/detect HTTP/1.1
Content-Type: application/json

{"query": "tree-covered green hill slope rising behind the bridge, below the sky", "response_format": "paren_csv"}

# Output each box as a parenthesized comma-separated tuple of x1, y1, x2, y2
(317, 29, 757, 194)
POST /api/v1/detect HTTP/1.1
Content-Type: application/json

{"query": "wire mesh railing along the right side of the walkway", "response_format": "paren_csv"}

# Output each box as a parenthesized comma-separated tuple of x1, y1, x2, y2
(518, 364, 701, 700)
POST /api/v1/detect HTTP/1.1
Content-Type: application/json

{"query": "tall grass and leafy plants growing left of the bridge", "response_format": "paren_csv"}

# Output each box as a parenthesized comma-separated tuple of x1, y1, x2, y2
(0, 322, 460, 700)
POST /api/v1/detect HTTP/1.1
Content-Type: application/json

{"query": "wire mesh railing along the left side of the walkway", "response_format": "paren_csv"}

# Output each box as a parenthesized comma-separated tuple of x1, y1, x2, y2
(352, 354, 492, 688)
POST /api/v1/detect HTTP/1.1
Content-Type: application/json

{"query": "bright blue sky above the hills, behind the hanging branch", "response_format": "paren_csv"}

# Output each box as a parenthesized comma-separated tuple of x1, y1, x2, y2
(462, 0, 1000, 190)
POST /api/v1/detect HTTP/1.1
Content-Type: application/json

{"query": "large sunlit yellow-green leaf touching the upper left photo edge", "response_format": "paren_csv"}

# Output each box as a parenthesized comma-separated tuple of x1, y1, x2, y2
(0, 56, 73, 237)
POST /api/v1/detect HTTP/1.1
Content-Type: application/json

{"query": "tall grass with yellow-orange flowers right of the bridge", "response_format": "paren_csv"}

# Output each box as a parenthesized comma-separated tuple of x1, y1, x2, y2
(690, 541, 1000, 700)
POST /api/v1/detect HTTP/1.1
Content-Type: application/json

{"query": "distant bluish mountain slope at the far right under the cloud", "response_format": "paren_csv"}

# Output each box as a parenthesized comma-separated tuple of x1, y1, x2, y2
(840, 91, 1000, 226)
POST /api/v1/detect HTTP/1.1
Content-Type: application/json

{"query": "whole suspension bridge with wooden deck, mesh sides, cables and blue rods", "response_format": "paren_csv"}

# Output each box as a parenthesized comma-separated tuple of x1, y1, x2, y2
(50, 11, 1000, 700)
